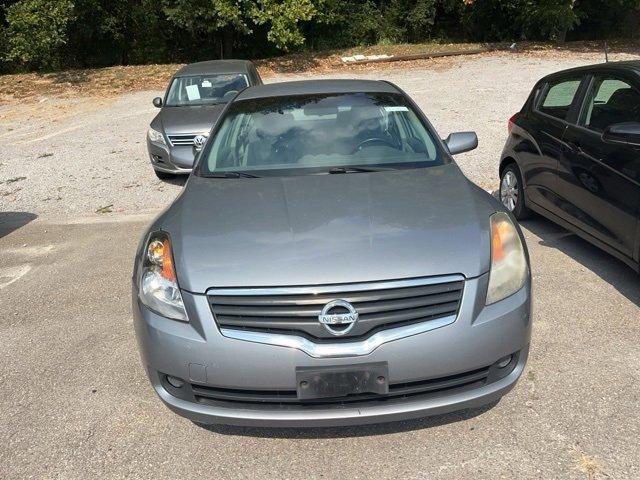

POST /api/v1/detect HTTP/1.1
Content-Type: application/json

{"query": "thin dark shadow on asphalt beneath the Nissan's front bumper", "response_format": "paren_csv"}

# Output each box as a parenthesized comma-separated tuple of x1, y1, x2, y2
(196, 401, 498, 439)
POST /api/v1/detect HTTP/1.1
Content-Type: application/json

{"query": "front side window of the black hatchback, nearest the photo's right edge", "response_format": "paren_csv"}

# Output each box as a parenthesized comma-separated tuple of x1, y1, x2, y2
(581, 77, 640, 132)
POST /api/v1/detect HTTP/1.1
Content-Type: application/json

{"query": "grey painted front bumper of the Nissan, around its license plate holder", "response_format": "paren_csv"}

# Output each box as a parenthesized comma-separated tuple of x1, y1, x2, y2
(133, 275, 531, 427)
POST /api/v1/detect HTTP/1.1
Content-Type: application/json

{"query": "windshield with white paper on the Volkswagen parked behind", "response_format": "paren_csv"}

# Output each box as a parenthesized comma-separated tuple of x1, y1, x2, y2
(166, 73, 249, 107)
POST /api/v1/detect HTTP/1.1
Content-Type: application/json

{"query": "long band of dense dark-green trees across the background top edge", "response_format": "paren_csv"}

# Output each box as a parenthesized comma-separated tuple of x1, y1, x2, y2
(0, 0, 640, 71)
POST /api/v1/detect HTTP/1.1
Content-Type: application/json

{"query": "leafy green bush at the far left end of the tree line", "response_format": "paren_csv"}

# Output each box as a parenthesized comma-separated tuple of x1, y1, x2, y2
(5, 0, 74, 68)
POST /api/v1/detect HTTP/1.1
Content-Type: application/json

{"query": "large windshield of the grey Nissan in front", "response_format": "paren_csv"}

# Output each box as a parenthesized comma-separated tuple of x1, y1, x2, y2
(200, 93, 442, 176)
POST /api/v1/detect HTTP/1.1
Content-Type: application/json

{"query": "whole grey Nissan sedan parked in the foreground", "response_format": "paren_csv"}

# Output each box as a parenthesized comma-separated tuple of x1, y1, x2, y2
(133, 80, 531, 427)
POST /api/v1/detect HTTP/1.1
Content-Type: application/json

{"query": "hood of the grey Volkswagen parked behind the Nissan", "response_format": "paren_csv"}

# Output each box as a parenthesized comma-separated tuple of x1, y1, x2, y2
(152, 104, 225, 135)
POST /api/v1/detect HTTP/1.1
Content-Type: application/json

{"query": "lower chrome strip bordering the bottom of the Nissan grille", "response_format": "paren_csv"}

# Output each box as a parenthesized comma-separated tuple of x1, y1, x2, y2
(220, 315, 456, 358)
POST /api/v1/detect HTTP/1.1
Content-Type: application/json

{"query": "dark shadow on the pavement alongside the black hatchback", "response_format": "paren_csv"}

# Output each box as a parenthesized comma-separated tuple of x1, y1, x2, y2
(522, 216, 640, 306)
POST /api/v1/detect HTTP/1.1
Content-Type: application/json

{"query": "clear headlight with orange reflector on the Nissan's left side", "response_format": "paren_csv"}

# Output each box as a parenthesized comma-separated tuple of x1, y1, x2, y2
(139, 232, 188, 322)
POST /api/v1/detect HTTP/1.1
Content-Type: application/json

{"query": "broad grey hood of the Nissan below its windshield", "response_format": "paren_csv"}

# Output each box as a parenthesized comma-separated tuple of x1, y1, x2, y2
(157, 164, 498, 293)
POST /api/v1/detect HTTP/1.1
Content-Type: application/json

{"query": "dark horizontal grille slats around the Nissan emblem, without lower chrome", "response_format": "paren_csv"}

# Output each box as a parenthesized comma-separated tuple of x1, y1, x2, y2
(208, 277, 464, 342)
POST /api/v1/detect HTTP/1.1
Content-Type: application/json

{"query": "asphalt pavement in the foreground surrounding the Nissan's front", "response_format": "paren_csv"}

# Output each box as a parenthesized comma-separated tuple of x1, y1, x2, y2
(0, 213, 640, 479)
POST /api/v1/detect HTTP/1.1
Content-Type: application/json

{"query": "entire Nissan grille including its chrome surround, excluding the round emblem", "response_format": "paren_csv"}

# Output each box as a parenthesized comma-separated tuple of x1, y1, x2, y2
(206, 275, 465, 357)
